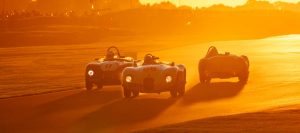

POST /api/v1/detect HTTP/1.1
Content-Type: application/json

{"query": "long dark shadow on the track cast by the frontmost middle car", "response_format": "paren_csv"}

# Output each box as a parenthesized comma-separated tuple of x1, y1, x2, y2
(76, 96, 177, 132)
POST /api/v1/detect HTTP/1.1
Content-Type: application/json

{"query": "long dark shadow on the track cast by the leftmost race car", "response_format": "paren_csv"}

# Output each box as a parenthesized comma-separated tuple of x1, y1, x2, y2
(13, 87, 122, 132)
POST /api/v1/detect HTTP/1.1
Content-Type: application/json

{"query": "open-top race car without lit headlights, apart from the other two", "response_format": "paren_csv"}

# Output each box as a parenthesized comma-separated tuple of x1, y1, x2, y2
(198, 46, 249, 83)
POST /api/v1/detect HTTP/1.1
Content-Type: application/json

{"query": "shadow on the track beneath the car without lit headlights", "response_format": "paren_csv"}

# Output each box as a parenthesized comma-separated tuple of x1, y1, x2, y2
(182, 82, 245, 105)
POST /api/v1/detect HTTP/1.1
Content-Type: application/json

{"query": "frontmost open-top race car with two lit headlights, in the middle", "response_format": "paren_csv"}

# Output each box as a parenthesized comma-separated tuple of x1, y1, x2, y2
(122, 54, 186, 98)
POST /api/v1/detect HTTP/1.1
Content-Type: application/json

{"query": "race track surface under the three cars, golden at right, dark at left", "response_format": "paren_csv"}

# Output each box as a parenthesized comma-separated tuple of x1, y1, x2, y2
(0, 35, 300, 133)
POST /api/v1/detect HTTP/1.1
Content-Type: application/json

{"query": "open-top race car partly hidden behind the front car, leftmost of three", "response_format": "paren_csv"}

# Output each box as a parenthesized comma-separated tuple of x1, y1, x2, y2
(85, 46, 134, 90)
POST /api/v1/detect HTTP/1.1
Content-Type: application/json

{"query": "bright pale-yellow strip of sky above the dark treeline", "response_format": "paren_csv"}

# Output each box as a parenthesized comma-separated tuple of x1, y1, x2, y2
(140, 0, 300, 7)
